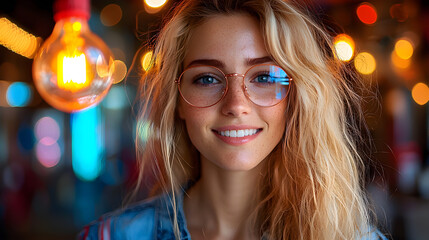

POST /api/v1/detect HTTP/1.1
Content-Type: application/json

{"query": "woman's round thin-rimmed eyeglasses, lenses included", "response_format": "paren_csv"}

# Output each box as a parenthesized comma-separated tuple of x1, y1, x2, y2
(175, 64, 292, 108)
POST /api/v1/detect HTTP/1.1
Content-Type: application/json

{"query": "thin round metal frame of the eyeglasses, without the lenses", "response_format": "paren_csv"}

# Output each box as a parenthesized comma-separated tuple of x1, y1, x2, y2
(174, 63, 293, 108)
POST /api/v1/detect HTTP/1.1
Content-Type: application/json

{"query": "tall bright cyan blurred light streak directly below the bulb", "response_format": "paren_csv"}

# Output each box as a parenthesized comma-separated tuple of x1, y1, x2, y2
(71, 106, 104, 181)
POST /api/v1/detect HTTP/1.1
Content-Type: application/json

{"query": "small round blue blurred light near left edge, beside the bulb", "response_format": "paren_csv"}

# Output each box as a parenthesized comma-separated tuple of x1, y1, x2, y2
(6, 82, 32, 107)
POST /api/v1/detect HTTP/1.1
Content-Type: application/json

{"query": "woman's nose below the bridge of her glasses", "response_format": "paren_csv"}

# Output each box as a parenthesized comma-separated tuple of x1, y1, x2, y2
(221, 75, 252, 117)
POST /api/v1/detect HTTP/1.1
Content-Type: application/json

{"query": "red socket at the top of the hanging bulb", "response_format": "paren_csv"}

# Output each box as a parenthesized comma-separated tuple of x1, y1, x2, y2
(54, 0, 91, 22)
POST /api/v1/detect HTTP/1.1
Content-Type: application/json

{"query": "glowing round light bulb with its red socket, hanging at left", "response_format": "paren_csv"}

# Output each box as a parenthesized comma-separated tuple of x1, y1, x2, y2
(33, 0, 114, 112)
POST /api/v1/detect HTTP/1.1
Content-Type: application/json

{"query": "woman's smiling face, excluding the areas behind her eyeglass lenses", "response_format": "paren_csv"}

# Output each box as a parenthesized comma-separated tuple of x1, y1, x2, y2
(178, 14, 287, 171)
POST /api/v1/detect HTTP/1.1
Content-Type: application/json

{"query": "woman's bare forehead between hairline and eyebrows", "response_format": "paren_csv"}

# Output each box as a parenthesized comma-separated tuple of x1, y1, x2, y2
(184, 14, 269, 67)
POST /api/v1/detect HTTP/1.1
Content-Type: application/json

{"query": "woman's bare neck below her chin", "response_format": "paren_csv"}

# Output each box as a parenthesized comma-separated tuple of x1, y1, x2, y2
(184, 159, 262, 239)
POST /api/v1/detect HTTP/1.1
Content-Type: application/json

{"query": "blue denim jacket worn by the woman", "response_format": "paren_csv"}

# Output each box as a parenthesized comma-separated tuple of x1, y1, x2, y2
(78, 189, 387, 240)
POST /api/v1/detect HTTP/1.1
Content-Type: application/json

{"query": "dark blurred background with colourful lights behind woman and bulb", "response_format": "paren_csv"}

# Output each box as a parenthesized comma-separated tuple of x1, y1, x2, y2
(0, 0, 429, 240)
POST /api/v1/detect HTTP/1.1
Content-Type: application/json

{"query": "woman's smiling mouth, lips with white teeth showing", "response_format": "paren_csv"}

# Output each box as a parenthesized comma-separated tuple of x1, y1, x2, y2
(213, 128, 262, 146)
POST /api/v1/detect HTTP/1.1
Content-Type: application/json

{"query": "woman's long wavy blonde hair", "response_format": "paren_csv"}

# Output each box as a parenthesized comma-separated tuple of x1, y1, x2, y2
(136, 0, 371, 240)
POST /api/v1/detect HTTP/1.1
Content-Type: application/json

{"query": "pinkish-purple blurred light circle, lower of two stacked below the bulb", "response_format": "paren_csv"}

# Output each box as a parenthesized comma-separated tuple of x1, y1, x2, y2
(36, 141, 61, 168)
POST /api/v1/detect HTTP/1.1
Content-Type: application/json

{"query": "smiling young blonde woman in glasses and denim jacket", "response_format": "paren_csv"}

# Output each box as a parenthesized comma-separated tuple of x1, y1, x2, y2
(79, 0, 385, 240)
